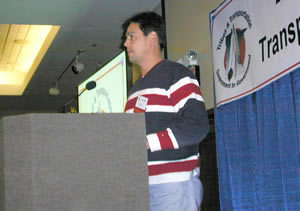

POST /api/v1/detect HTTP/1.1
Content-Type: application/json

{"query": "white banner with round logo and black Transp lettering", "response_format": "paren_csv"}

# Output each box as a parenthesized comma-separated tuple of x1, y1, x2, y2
(210, 0, 300, 106)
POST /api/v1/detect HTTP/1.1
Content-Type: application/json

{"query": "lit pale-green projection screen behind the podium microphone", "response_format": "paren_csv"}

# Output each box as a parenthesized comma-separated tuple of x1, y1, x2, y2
(78, 51, 127, 113)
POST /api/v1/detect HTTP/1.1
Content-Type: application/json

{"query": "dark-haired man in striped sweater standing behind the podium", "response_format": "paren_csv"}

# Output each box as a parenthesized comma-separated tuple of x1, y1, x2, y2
(122, 12, 209, 211)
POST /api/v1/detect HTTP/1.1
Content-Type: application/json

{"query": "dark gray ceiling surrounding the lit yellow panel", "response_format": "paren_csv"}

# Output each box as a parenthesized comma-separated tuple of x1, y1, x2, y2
(0, 0, 160, 114)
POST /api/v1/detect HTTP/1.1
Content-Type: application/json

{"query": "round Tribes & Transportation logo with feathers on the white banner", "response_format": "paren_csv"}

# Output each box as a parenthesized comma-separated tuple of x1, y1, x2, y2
(216, 11, 252, 88)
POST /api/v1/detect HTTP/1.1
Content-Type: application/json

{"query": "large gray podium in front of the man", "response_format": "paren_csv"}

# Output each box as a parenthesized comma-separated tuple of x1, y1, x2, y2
(0, 114, 149, 211)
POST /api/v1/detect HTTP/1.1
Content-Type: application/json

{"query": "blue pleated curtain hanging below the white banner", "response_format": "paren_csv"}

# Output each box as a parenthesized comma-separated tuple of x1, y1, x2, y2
(215, 68, 300, 211)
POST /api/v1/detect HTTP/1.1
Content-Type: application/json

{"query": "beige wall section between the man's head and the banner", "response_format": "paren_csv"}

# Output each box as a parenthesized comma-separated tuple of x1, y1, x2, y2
(165, 0, 223, 109)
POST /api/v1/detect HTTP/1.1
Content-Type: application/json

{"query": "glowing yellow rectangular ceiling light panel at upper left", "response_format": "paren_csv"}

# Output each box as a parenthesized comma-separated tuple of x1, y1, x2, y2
(0, 24, 60, 95)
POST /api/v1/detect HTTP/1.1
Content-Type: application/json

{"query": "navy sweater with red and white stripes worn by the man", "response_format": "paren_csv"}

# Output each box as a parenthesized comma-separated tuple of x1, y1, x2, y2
(125, 60, 208, 184)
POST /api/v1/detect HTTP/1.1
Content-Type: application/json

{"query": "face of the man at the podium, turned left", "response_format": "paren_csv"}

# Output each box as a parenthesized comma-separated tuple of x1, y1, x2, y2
(124, 23, 150, 64)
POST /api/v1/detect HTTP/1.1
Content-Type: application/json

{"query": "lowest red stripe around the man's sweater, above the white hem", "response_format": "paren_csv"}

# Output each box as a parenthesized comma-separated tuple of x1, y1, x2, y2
(148, 159, 200, 176)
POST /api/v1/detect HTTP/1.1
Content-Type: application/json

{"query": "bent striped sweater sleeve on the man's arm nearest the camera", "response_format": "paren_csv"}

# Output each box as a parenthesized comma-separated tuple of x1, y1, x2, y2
(147, 71, 209, 152)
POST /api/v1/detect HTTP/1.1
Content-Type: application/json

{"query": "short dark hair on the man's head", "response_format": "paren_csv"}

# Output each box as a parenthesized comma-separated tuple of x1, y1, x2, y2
(121, 12, 166, 50)
